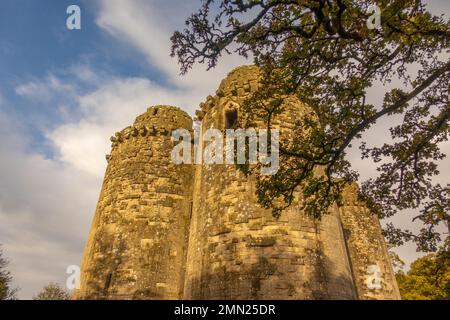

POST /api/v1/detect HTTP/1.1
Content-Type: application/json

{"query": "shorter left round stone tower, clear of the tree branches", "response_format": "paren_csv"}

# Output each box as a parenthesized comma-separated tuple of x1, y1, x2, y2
(75, 106, 192, 299)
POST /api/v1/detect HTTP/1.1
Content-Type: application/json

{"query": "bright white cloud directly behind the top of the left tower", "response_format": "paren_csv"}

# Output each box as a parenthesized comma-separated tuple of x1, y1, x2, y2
(47, 78, 200, 177)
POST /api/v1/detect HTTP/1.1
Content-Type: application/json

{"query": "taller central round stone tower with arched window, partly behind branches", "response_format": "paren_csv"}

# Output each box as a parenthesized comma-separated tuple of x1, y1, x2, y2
(184, 66, 356, 299)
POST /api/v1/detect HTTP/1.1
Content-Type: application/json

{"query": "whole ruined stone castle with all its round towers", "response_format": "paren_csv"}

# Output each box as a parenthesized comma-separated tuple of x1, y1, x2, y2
(75, 66, 400, 299)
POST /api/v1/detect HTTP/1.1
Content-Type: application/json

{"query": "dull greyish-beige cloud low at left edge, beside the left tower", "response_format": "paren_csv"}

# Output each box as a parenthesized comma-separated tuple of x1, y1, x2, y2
(0, 112, 101, 298)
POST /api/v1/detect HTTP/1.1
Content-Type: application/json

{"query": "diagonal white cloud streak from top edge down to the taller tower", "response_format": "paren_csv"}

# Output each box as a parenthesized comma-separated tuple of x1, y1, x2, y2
(97, 0, 251, 97)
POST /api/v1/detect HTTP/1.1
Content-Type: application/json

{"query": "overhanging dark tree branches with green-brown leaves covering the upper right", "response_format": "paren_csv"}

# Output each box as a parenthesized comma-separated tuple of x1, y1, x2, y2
(171, 0, 450, 251)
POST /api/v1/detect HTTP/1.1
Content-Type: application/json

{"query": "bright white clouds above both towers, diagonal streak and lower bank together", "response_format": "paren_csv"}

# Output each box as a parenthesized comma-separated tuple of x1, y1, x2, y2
(47, 0, 250, 180)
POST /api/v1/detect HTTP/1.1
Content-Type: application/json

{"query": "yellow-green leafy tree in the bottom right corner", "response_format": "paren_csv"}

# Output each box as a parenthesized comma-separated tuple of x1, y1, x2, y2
(396, 246, 450, 300)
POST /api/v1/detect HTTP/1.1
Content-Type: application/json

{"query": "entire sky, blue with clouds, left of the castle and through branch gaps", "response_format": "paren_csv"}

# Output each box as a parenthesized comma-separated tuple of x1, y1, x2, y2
(0, 0, 450, 299)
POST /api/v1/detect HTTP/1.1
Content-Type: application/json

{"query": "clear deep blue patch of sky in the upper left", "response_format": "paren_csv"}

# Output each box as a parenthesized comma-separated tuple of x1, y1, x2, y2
(0, 0, 170, 156)
